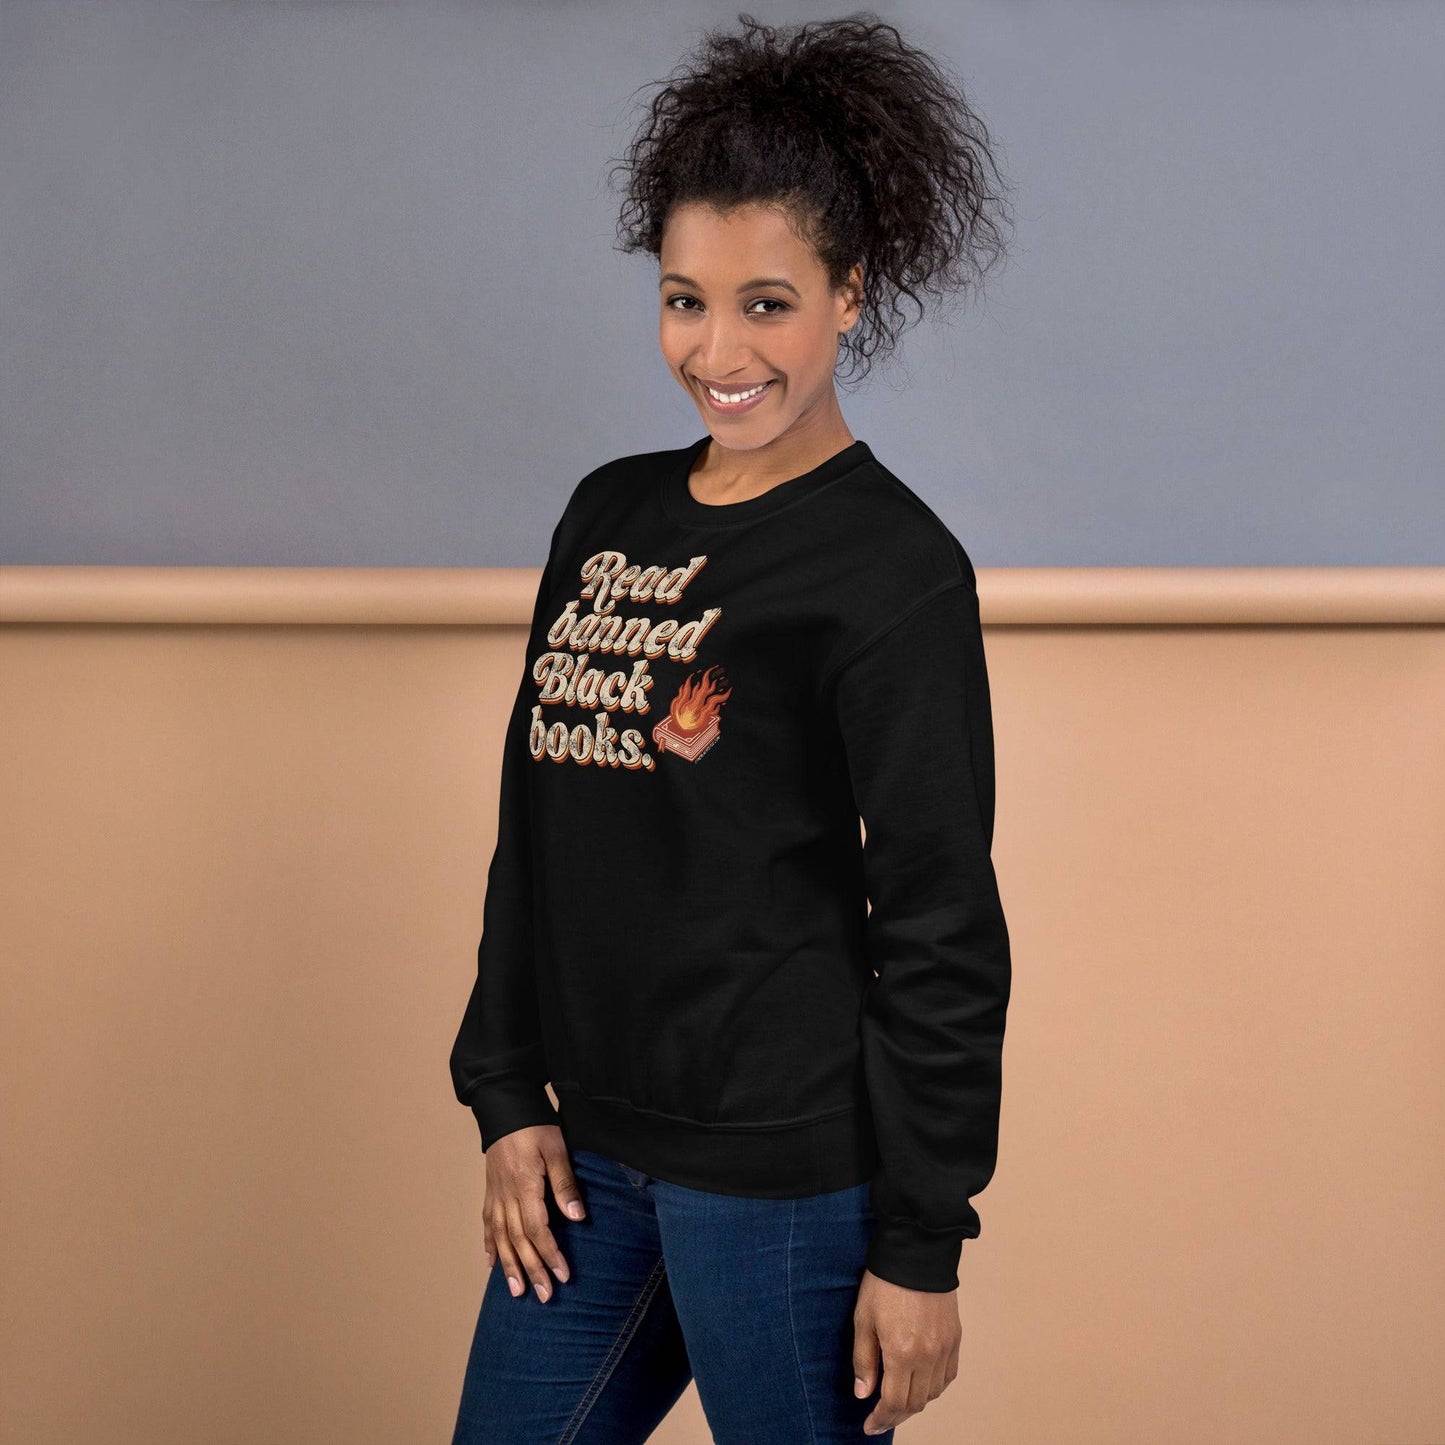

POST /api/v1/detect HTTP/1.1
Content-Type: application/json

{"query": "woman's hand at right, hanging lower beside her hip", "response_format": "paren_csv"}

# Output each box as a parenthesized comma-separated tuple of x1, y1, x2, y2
(853, 1270, 964, 1435)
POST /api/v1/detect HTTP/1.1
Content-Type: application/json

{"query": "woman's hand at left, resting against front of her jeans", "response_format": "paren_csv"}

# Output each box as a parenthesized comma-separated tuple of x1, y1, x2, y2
(481, 1124, 587, 1303)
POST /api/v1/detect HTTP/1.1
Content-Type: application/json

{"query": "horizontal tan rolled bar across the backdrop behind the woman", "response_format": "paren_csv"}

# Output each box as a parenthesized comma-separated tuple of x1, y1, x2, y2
(0, 566, 1445, 627)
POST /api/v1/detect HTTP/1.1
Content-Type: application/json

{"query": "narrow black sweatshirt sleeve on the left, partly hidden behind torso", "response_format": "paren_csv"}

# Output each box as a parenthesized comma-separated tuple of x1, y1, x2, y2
(451, 523, 561, 1152)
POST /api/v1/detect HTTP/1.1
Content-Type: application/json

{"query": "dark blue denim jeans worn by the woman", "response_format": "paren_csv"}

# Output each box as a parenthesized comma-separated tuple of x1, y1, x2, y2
(452, 1149, 893, 1445)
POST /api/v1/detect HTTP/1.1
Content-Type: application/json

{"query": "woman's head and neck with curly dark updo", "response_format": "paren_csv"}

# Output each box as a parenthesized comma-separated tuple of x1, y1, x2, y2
(609, 16, 1007, 504)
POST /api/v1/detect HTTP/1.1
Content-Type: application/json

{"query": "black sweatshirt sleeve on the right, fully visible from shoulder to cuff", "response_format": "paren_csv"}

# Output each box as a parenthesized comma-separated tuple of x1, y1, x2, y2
(834, 566, 1012, 1292)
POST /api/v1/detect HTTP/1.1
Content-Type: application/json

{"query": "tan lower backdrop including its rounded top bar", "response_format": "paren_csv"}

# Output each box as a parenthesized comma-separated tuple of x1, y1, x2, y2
(0, 568, 1445, 1445)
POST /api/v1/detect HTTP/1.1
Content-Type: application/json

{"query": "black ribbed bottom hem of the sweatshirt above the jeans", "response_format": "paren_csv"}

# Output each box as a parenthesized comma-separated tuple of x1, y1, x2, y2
(552, 1079, 879, 1199)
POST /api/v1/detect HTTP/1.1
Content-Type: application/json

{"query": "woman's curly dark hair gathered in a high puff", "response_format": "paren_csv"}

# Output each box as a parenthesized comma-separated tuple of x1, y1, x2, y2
(608, 10, 1012, 376)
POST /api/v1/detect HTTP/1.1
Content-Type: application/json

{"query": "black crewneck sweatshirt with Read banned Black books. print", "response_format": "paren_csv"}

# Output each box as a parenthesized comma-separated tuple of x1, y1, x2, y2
(451, 435, 1010, 1290)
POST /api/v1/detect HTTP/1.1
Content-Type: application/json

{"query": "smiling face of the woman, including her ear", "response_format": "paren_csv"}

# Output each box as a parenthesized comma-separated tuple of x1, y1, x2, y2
(659, 204, 863, 449)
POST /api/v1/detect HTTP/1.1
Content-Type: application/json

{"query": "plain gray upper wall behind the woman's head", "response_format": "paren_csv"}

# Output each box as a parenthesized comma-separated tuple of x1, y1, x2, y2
(0, 0, 1445, 566)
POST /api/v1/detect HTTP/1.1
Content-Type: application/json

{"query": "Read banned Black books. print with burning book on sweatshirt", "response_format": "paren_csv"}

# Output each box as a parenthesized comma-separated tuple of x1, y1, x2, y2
(527, 551, 733, 772)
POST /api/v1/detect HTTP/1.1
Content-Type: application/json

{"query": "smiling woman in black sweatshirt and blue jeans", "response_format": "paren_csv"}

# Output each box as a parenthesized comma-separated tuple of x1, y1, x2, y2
(451, 13, 1010, 1445)
